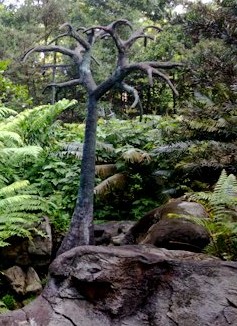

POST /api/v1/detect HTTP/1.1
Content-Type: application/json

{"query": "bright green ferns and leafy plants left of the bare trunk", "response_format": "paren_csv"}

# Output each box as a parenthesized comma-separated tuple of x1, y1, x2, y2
(0, 100, 77, 242)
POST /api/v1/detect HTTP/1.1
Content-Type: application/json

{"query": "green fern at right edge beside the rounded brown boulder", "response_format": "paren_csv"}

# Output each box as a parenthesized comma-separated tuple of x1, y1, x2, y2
(190, 170, 237, 260)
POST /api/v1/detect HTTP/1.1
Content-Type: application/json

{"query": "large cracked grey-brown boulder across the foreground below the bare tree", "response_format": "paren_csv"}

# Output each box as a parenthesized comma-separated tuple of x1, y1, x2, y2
(0, 245, 237, 326)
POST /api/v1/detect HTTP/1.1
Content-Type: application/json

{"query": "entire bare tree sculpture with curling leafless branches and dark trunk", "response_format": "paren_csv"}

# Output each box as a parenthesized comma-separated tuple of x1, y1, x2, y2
(23, 19, 181, 253)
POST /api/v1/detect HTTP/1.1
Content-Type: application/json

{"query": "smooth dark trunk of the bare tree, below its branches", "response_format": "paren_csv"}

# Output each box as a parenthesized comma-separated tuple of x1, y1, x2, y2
(57, 95, 97, 255)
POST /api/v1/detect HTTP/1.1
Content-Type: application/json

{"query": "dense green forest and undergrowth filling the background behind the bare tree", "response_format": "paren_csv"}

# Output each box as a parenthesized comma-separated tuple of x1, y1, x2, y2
(0, 0, 237, 259)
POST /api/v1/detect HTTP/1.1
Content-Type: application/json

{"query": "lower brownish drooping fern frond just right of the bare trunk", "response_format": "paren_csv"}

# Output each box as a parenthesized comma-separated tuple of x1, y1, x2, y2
(94, 173, 127, 195)
